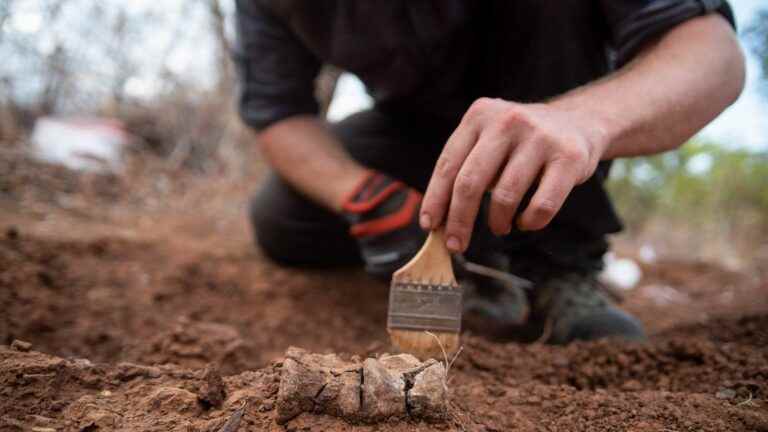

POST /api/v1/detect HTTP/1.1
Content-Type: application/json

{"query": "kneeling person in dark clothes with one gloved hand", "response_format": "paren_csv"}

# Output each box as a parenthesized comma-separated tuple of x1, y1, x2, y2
(234, 0, 744, 343)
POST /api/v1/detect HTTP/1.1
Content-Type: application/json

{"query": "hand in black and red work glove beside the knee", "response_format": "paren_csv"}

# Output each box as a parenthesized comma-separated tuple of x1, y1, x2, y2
(342, 171, 426, 279)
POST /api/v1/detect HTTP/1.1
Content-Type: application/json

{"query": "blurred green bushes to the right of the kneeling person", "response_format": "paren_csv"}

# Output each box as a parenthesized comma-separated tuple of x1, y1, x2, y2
(609, 141, 768, 231)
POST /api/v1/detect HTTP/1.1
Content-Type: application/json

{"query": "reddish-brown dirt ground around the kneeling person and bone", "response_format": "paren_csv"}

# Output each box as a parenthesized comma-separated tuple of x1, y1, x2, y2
(0, 151, 768, 432)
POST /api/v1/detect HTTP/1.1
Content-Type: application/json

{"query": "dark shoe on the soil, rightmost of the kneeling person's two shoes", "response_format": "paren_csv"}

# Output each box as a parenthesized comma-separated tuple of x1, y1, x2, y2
(531, 274, 646, 344)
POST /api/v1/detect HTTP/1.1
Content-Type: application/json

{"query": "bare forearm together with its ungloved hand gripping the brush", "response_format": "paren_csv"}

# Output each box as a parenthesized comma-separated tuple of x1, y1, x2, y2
(421, 15, 744, 246)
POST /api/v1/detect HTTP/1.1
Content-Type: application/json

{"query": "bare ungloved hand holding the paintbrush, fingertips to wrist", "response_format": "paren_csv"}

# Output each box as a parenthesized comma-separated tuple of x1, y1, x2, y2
(420, 98, 608, 252)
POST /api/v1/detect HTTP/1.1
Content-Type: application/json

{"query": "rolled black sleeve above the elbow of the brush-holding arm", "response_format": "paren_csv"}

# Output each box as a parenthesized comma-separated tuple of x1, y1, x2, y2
(600, 0, 736, 67)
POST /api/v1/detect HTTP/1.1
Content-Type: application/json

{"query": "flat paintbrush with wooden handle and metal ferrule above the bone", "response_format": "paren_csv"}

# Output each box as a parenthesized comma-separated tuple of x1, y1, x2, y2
(387, 228, 462, 359)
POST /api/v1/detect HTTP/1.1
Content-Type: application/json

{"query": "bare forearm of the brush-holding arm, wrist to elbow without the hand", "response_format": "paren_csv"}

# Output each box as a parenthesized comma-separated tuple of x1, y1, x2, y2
(551, 15, 745, 159)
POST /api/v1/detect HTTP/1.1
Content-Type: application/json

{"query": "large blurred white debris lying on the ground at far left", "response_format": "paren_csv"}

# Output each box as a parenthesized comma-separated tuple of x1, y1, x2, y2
(31, 117, 130, 172)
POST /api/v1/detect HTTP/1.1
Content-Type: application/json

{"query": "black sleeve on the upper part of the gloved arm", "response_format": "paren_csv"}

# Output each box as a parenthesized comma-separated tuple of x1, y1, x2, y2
(232, 0, 320, 129)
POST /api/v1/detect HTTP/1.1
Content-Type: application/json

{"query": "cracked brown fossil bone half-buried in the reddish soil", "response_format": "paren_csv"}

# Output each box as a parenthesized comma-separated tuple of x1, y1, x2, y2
(276, 348, 447, 424)
